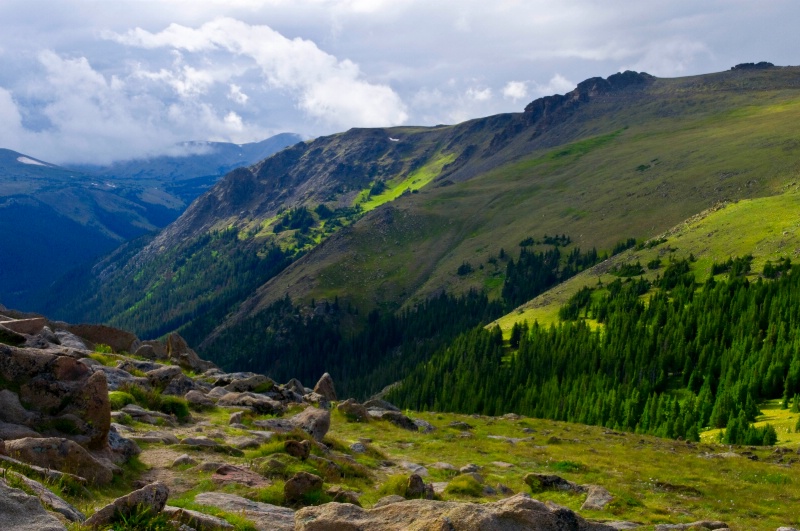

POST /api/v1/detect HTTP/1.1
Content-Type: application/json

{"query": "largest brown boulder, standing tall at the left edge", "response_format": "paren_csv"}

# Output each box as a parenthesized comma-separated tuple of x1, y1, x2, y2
(0, 345, 111, 450)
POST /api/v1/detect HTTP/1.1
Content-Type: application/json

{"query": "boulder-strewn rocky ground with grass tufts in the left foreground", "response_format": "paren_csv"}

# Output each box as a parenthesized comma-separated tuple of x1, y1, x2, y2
(0, 311, 793, 531)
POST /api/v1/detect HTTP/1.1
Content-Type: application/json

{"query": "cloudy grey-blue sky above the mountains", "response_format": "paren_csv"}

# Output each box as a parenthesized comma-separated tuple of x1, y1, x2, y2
(0, 0, 800, 164)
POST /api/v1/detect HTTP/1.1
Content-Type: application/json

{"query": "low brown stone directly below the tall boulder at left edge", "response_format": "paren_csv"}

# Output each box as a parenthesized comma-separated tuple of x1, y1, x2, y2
(6, 437, 114, 485)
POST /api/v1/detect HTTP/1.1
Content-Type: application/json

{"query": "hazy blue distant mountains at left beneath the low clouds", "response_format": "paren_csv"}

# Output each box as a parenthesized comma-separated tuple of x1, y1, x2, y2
(0, 134, 300, 309)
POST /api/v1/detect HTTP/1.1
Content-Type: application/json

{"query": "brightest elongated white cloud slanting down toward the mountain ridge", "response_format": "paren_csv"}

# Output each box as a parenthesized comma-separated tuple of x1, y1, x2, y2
(107, 18, 408, 128)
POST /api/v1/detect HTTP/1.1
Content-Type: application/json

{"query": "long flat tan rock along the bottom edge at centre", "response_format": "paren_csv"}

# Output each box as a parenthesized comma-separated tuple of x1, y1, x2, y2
(295, 494, 613, 531)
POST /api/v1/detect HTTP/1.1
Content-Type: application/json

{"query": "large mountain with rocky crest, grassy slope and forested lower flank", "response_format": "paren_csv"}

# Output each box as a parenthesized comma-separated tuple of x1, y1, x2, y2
(48, 67, 800, 392)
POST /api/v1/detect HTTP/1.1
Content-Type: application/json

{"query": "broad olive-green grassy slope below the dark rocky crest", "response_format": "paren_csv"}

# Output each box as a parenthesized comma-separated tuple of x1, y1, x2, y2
(239, 70, 800, 324)
